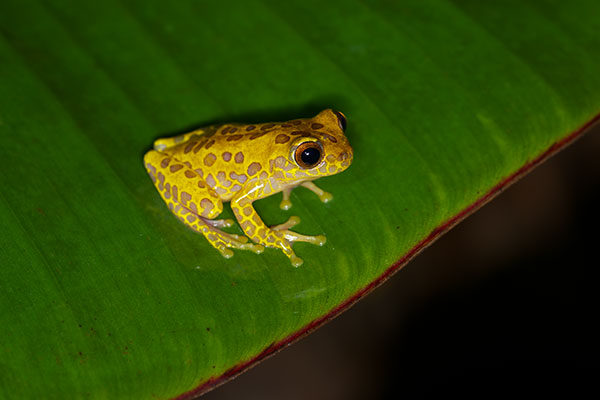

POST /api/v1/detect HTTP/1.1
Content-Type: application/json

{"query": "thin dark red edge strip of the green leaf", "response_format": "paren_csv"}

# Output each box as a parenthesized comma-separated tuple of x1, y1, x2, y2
(174, 114, 600, 400)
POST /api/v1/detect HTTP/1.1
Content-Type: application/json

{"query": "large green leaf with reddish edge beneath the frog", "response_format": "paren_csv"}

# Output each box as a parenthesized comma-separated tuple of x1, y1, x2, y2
(0, 0, 600, 398)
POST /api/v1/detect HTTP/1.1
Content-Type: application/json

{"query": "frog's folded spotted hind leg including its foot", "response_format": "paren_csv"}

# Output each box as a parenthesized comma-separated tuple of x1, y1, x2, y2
(144, 150, 263, 258)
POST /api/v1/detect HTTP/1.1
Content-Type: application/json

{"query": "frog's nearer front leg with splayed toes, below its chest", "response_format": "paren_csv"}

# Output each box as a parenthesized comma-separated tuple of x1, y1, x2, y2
(231, 182, 325, 267)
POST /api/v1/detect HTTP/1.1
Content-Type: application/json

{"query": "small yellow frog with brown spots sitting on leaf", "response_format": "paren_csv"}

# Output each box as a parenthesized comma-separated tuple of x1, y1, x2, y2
(144, 109, 354, 267)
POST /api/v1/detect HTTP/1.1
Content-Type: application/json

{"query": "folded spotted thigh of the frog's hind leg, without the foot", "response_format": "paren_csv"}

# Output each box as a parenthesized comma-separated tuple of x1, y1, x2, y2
(144, 150, 223, 219)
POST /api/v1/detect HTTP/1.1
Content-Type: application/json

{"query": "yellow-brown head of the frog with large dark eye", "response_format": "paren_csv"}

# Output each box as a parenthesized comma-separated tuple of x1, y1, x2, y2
(280, 109, 353, 179)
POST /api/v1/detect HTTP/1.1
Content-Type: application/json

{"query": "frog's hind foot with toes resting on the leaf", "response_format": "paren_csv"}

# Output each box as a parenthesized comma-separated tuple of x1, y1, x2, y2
(198, 217, 265, 258)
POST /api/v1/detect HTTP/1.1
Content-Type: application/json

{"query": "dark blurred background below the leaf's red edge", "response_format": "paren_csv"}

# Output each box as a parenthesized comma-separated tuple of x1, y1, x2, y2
(203, 125, 600, 400)
